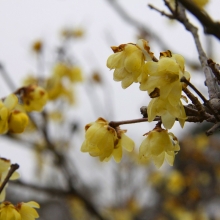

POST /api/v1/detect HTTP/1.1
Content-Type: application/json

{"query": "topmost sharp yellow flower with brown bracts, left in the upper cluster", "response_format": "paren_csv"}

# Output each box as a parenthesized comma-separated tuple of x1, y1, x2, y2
(107, 40, 153, 89)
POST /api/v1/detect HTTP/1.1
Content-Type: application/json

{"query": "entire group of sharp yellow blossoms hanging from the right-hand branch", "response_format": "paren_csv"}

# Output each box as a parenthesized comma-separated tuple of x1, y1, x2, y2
(81, 39, 190, 167)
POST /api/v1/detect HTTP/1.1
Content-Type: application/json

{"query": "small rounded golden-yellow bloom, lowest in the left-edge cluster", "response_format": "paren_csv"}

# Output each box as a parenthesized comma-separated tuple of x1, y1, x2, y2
(8, 109, 29, 133)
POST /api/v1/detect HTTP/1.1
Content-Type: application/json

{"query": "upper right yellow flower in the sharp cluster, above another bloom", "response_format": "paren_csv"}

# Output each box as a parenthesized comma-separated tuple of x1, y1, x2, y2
(140, 51, 190, 105)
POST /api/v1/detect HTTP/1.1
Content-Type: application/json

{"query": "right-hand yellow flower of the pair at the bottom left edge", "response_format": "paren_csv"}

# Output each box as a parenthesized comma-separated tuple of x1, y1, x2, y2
(16, 201, 40, 220)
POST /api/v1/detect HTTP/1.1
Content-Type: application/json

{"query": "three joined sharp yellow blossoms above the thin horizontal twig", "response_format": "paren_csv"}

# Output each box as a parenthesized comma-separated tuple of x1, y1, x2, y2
(107, 39, 190, 129)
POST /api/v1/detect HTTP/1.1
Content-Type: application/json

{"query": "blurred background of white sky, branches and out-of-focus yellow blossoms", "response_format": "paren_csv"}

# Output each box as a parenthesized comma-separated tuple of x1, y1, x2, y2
(0, 0, 220, 220)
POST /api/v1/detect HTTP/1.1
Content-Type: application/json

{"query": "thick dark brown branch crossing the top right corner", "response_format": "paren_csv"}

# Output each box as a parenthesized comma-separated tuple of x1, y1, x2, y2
(177, 0, 220, 39)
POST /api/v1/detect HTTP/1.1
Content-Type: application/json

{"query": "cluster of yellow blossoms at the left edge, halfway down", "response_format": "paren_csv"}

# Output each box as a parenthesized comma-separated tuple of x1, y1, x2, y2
(0, 85, 47, 134)
